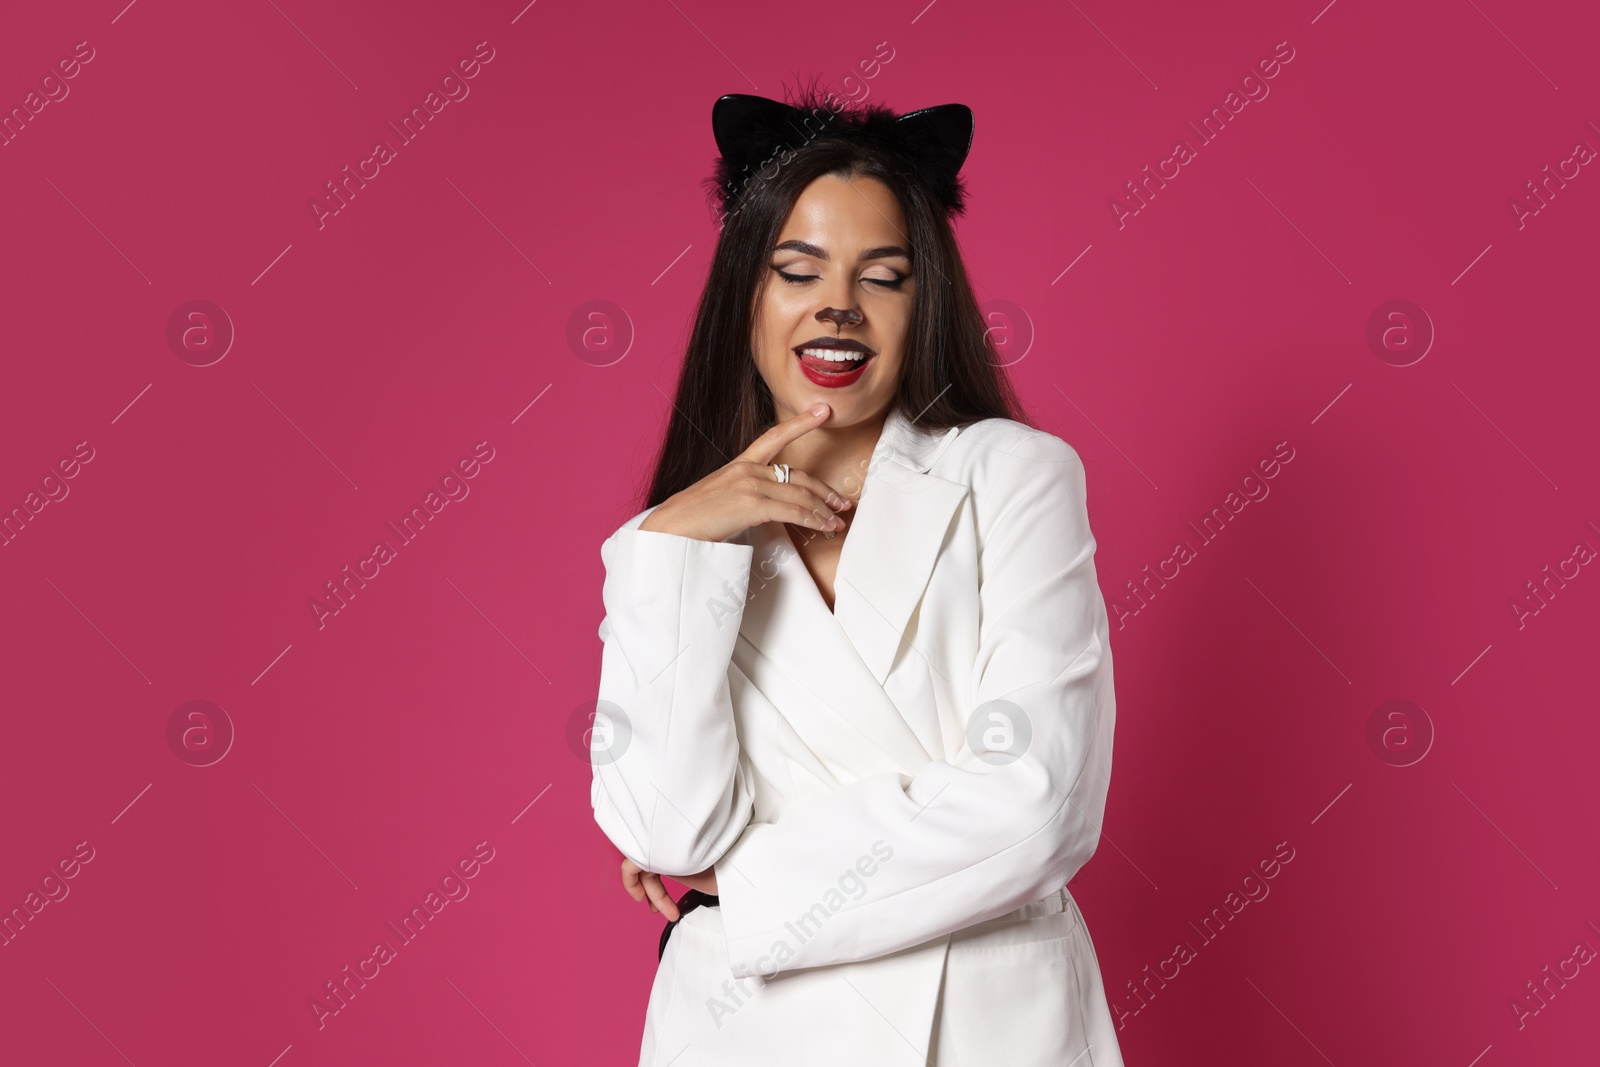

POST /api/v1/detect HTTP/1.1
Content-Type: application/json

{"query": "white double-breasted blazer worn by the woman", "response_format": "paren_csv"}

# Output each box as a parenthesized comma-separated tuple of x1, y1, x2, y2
(590, 405, 1122, 1067)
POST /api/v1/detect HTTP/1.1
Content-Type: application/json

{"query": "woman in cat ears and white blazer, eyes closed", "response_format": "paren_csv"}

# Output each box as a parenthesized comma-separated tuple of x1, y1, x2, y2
(592, 85, 1122, 1067)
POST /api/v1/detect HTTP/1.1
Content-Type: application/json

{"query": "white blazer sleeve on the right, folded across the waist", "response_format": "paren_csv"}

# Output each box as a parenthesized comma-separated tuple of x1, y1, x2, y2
(717, 434, 1115, 977)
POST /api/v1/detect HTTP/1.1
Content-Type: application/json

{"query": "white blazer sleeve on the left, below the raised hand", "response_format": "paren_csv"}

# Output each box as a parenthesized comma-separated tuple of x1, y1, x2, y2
(589, 510, 755, 875)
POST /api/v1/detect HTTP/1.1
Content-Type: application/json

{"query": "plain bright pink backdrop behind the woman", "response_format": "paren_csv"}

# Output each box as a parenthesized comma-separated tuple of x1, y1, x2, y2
(0, 0, 1600, 1067)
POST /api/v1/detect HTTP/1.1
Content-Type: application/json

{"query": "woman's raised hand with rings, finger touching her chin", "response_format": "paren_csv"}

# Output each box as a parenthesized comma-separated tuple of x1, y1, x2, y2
(635, 405, 851, 547)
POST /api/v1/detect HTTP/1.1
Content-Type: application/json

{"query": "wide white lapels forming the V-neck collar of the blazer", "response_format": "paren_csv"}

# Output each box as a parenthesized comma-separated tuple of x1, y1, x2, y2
(739, 403, 968, 766)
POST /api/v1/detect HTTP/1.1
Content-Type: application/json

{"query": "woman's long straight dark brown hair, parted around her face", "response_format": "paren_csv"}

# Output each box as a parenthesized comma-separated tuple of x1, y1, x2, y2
(643, 86, 1029, 507)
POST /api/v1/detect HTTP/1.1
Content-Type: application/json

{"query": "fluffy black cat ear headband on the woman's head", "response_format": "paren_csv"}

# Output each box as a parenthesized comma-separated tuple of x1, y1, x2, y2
(710, 93, 973, 214)
